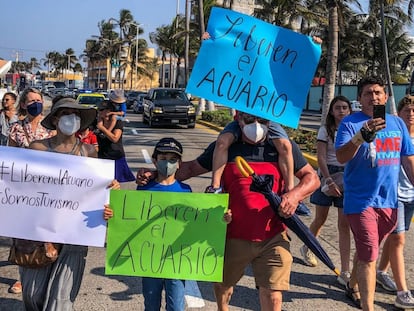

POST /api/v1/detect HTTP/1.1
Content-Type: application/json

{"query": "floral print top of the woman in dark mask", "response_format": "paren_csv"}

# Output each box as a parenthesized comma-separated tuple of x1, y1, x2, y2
(9, 118, 55, 148)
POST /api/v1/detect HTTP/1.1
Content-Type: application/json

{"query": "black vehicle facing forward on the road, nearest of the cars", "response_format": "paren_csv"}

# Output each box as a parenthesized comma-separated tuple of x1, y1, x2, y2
(143, 88, 196, 128)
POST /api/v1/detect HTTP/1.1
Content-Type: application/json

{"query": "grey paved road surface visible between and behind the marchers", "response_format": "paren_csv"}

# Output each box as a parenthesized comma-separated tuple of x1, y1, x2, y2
(0, 106, 414, 311)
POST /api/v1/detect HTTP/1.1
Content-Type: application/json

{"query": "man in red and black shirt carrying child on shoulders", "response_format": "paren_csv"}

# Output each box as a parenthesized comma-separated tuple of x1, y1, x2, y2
(137, 114, 320, 311)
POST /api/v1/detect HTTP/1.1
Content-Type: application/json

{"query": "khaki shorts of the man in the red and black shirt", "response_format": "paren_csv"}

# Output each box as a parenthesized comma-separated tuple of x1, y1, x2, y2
(223, 231, 293, 291)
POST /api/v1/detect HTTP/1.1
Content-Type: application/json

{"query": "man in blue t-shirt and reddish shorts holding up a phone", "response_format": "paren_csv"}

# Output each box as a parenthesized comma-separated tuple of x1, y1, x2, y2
(335, 77, 414, 310)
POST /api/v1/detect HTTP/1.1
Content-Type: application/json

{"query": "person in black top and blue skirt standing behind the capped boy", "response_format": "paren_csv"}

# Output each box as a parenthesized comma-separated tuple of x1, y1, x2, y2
(96, 100, 135, 182)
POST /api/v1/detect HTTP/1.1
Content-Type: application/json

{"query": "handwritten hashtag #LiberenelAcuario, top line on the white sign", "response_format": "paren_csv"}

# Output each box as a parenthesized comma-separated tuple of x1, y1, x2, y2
(0, 161, 93, 188)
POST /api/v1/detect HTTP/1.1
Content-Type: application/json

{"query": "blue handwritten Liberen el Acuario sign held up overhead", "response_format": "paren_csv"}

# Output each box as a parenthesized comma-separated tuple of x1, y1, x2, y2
(186, 7, 321, 128)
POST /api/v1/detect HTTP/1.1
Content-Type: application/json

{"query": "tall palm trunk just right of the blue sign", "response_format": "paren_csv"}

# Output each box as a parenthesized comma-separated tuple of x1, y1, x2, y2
(321, 0, 339, 125)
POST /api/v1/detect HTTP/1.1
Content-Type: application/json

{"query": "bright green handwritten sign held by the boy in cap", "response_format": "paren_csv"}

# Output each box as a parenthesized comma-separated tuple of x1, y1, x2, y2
(105, 190, 228, 282)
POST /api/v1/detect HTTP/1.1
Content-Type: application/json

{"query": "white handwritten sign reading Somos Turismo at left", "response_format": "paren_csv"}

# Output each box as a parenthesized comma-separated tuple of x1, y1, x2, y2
(0, 146, 115, 246)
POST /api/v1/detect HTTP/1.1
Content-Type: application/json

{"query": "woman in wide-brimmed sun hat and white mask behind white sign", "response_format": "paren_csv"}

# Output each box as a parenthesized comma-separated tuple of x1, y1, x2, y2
(20, 97, 120, 311)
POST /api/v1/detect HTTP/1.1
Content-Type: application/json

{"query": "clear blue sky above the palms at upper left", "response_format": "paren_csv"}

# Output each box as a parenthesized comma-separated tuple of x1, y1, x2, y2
(0, 0, 185, 66)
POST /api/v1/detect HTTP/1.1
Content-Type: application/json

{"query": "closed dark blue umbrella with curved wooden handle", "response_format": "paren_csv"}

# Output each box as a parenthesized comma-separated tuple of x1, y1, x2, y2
(236, 156, 340, 275)
